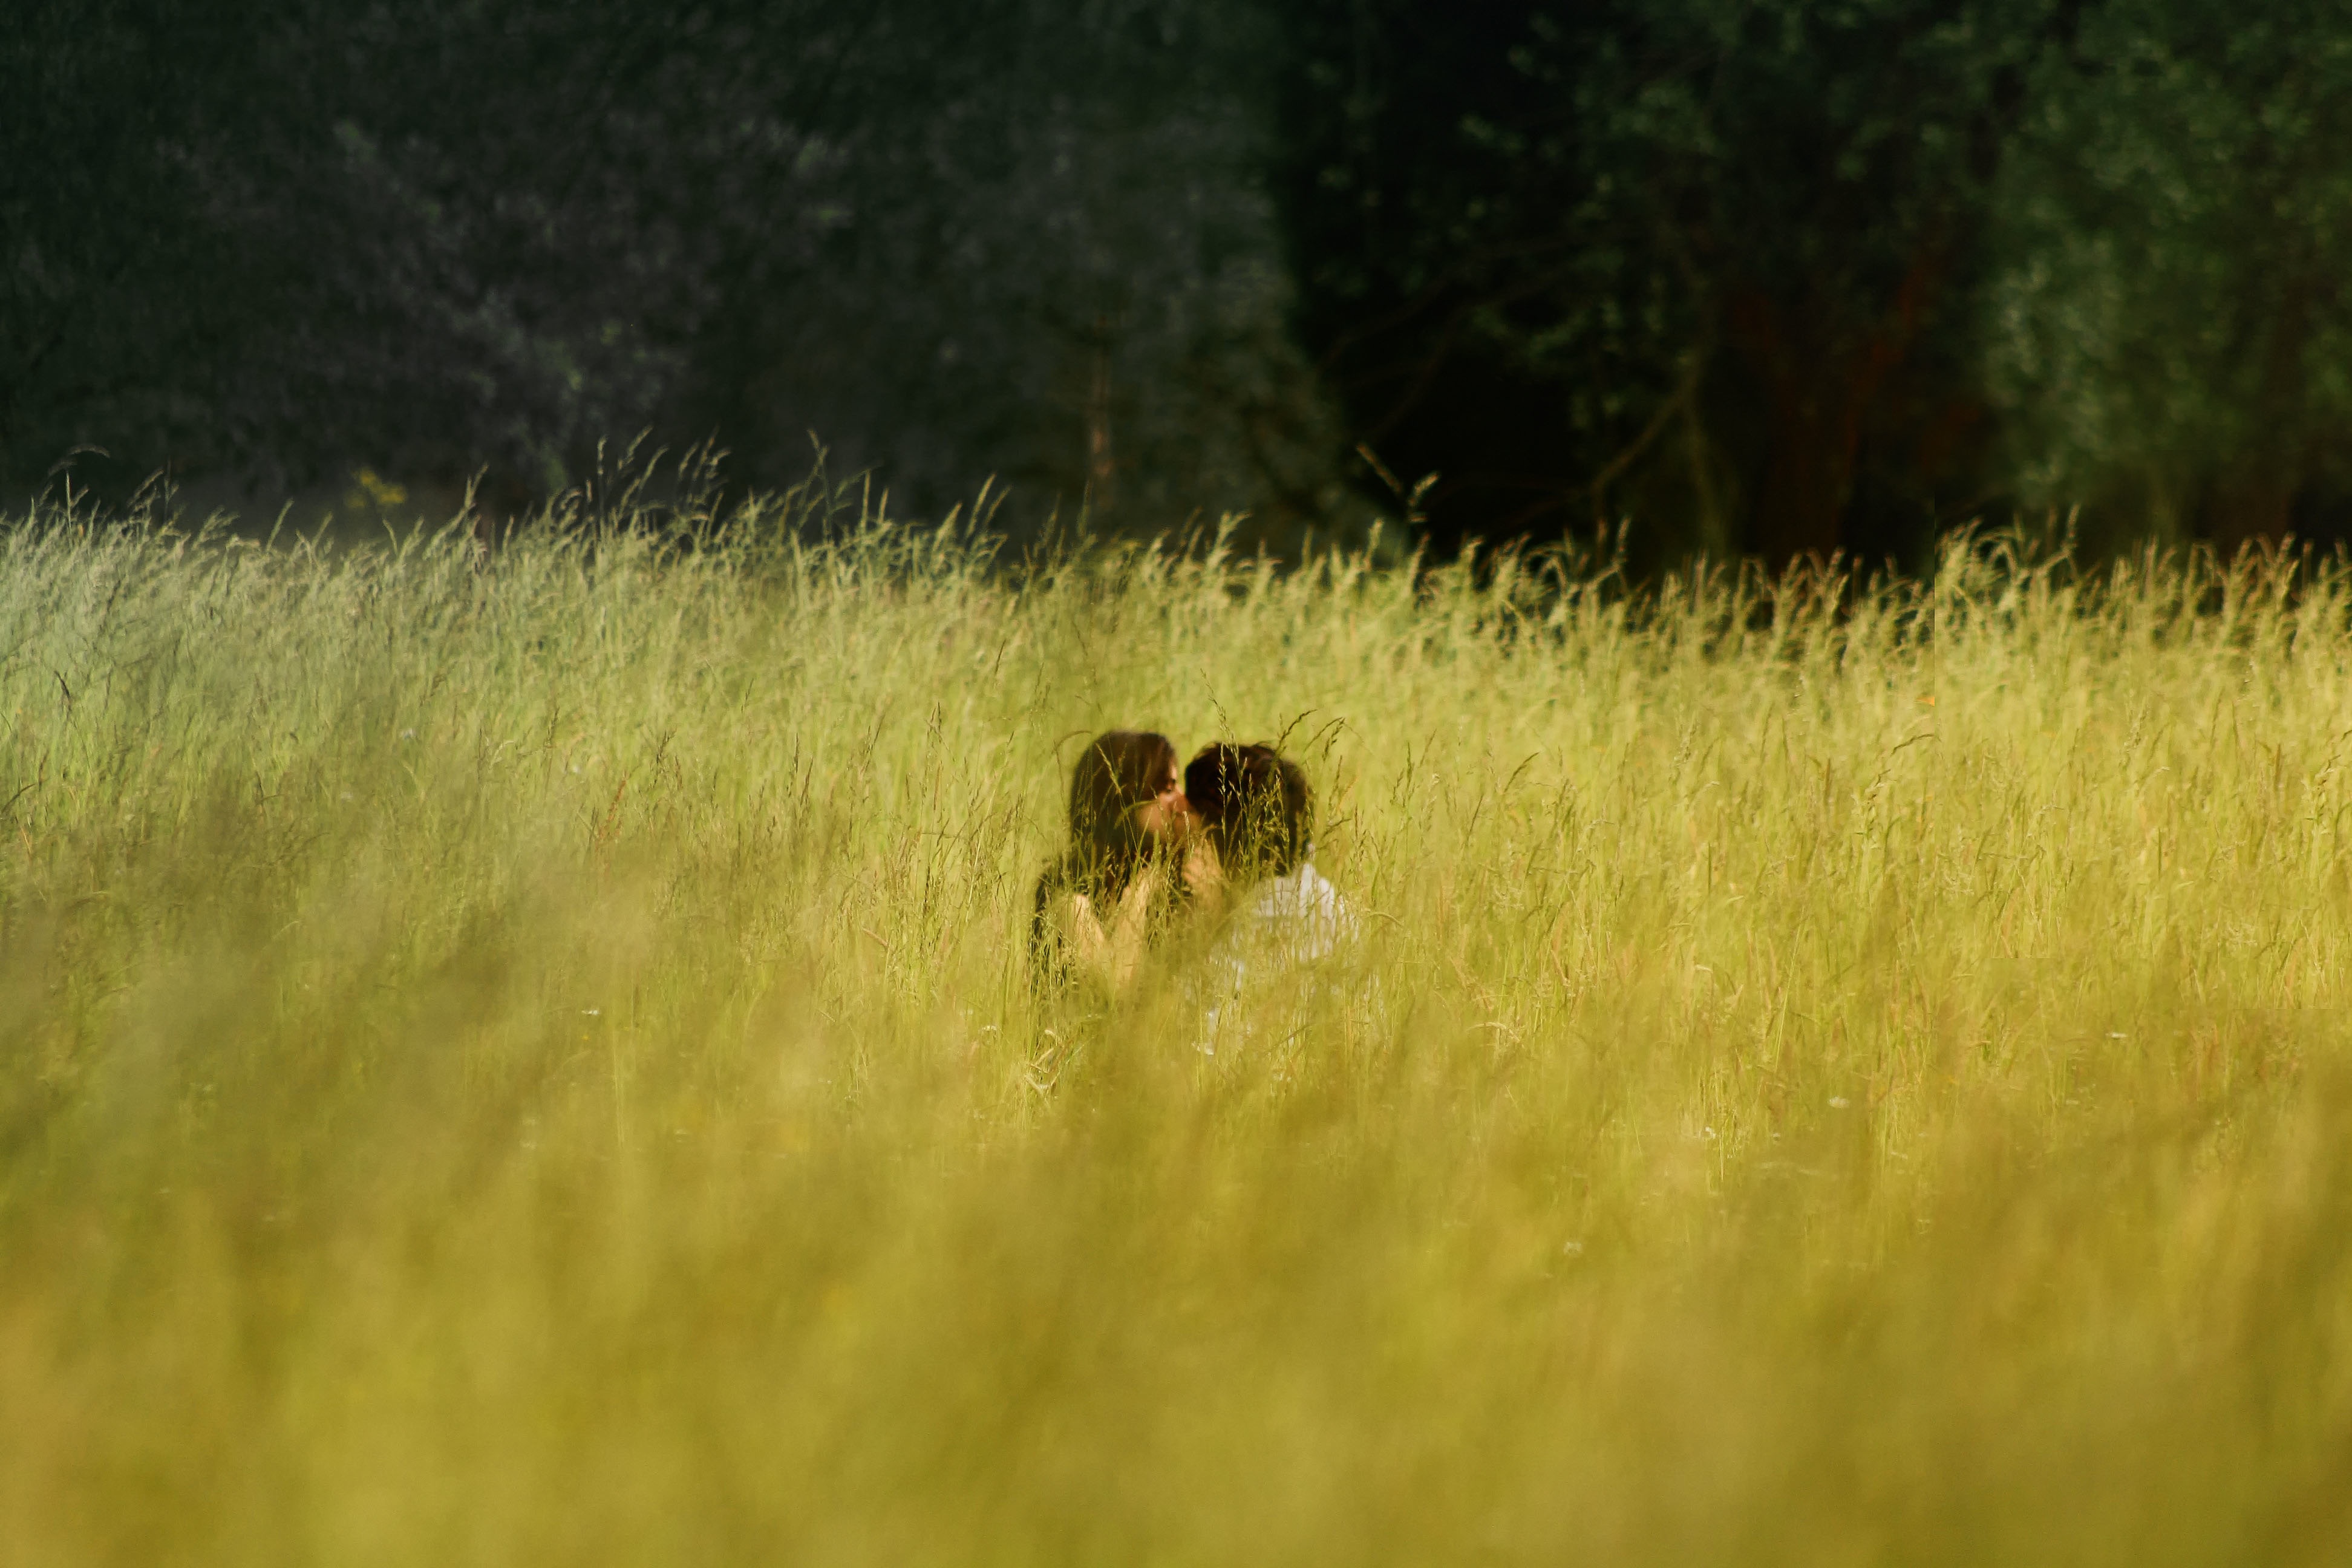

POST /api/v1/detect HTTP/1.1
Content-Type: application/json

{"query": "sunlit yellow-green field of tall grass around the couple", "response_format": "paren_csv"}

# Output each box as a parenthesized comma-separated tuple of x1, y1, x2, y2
(0, 484, 2352, 1568)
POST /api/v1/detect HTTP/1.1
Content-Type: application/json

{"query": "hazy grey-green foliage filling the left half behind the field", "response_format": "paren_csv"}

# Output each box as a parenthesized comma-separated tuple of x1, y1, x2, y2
(0, 0, 1331, 534)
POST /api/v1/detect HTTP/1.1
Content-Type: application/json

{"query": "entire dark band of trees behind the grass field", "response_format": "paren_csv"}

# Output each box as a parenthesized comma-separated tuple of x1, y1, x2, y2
(0, 0, 2352, 567)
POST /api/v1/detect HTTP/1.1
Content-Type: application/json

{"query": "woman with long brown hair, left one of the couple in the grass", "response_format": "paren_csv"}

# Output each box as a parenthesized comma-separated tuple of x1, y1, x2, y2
(1030, 729, 1197, 992)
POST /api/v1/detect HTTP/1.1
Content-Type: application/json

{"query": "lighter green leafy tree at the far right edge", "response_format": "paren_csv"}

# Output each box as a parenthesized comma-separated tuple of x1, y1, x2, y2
(1987, 0, 2352, 547)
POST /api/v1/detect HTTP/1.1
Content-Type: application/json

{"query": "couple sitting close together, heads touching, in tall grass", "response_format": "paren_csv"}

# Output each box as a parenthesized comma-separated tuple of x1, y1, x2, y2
(1030, 729, 1354, 1025)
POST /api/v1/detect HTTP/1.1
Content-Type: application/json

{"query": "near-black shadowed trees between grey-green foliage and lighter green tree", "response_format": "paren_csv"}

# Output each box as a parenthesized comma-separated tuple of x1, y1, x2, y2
(1289, 0, 2051, 557)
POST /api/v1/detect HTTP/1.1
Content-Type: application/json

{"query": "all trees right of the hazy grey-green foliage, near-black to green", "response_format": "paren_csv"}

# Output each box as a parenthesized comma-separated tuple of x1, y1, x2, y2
(1284, 0, 2352, 564)
